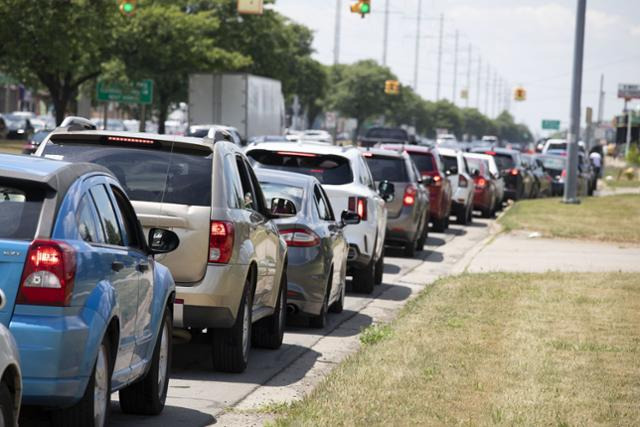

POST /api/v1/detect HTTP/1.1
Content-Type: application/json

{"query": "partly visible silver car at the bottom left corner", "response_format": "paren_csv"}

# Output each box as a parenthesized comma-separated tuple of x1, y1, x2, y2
(0, 324, 22, 427)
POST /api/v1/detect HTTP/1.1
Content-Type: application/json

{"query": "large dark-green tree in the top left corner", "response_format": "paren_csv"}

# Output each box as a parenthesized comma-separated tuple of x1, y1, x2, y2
(0, 0, 118, 124)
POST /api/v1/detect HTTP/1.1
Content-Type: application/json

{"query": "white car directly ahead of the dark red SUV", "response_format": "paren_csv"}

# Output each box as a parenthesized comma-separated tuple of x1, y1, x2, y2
(438, 148, 475, 225)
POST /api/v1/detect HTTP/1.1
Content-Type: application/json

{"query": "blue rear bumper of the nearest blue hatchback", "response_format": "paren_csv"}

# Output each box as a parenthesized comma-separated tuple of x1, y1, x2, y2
(10, 306, 106, 407)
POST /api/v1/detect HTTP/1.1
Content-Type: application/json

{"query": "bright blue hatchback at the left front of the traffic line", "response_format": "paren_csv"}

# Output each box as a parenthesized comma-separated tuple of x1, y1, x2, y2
(0, 155, 179, 426)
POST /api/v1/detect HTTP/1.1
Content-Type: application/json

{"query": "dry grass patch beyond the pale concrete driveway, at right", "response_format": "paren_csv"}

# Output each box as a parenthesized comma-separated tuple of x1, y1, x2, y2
(500, 194, 640, 243)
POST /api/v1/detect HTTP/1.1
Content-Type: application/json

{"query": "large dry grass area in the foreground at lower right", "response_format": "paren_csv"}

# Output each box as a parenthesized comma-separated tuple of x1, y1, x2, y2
(275, 273, 640, 426)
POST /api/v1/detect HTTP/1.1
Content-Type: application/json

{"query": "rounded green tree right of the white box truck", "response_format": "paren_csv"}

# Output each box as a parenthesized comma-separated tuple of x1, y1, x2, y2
(328, 60, 396, 135)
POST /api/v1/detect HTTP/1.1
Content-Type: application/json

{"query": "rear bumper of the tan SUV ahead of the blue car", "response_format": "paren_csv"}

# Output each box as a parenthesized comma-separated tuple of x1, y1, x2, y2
(173, 264, 249, 328)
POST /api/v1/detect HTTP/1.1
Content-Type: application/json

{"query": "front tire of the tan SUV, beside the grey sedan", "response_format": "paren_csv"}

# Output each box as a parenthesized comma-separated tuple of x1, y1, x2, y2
(251, 266, 288, 350)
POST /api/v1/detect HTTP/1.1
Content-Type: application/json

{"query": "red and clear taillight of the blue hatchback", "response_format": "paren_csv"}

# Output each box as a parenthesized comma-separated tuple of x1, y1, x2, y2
(17, 240, 76, 306)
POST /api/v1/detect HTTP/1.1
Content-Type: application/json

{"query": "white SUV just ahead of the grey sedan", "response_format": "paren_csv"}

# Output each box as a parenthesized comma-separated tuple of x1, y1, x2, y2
(246, 143, 393, 293)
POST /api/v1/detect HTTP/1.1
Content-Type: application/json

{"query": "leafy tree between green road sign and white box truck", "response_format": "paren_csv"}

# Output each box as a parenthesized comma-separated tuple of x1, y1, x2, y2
(117, 1, 250, 133)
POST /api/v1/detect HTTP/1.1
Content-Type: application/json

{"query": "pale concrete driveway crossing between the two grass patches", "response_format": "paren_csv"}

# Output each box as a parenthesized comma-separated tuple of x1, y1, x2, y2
(464, 231, 640, 273)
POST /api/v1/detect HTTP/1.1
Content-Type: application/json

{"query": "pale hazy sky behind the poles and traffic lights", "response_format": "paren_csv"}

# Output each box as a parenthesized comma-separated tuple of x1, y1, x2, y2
(273, 0, 640, 135)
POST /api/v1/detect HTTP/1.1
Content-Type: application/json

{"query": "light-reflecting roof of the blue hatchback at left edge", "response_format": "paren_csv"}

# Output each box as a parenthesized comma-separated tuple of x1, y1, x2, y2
(0, 154, 113, 194)
